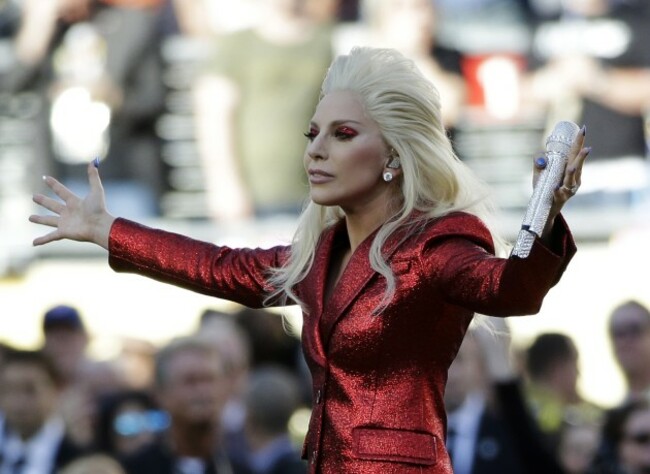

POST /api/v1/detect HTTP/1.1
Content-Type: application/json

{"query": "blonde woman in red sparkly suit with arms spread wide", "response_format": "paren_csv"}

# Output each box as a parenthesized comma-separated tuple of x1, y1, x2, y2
(30, 48, 588, 474)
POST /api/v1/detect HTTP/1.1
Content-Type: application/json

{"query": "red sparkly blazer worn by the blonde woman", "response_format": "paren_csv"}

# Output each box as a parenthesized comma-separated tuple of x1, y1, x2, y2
(109, 213, 575, 474)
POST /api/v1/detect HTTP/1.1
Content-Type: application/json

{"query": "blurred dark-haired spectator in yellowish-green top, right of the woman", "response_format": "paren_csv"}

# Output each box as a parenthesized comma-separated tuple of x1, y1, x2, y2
(526, 332, 602, 453)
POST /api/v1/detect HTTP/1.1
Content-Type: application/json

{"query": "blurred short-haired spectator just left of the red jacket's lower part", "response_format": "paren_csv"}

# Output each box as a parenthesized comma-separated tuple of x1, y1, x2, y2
(244, 365, 307, 474)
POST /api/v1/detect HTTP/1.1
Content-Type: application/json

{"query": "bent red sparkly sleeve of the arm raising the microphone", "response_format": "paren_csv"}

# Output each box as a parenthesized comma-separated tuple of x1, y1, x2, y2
(426, 216, 576, 316)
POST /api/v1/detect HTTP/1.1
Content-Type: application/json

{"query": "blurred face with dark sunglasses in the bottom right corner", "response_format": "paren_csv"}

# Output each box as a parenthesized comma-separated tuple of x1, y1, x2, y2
(619, 410, 650, 474)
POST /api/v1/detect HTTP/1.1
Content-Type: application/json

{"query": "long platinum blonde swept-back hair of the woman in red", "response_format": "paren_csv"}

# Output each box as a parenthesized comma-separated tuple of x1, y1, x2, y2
(262, 47, 500, 312)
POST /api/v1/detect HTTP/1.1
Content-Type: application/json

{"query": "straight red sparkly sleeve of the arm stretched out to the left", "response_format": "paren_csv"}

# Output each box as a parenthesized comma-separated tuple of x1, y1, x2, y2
(108, 219, 288, 307)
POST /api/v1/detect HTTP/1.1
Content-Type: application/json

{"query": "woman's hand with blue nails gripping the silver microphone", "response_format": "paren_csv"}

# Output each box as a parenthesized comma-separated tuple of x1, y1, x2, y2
(533, 126, 591, 238)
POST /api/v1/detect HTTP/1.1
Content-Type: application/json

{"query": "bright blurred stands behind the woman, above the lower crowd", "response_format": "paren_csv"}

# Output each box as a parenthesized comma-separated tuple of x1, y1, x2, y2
(0, 0, 650, 466)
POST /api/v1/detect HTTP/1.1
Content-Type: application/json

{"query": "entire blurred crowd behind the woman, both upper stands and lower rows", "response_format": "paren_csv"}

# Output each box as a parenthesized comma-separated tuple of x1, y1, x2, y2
(0, 0, 650, 474)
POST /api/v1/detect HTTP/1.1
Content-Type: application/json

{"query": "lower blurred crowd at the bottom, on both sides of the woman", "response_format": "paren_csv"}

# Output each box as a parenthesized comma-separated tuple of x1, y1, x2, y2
(6, 300, 650, 474)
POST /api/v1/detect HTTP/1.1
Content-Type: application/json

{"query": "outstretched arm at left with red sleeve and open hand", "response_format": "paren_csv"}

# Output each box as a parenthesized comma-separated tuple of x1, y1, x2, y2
(29, 162, 286, 307)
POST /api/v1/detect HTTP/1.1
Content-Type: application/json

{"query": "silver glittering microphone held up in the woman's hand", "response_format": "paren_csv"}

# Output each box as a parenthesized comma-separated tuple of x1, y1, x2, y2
(511, 121, 580, 258)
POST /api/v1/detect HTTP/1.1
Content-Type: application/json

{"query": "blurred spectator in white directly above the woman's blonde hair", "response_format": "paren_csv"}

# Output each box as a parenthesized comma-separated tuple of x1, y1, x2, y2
(354, 0, 467, 133)
